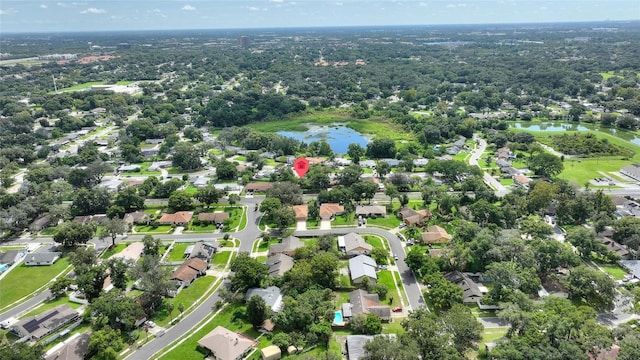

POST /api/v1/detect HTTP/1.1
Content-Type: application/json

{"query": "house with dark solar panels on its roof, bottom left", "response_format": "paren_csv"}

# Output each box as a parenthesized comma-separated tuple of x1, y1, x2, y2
(10, 304, 80, 341)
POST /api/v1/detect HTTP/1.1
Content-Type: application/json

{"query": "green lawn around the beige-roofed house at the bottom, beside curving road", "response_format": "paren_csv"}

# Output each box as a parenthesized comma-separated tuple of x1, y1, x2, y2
(160, 304, 258, 360)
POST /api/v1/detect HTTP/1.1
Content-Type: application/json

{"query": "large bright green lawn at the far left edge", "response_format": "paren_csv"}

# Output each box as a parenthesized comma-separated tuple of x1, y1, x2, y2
(0, 258, 69, 310)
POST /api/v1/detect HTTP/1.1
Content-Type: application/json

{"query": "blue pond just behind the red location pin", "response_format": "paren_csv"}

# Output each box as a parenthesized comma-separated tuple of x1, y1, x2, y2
(277, 124, 369, 154)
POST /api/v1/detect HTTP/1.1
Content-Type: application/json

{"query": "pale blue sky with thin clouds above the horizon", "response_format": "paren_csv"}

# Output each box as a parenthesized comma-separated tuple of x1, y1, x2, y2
(0, 0, 640, 33)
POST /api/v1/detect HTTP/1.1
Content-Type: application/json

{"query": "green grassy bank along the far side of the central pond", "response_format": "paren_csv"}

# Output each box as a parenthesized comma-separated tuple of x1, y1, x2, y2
(247, 109, 415, 140)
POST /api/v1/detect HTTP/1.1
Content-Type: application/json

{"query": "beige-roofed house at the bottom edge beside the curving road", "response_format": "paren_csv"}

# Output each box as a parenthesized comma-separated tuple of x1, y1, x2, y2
(198, 326, 258, 360)
